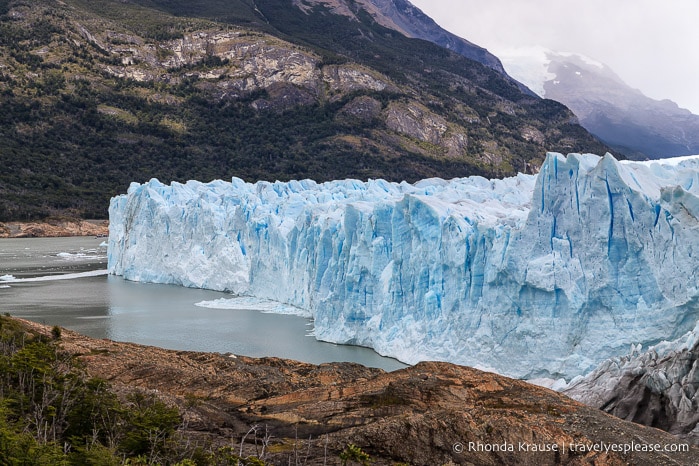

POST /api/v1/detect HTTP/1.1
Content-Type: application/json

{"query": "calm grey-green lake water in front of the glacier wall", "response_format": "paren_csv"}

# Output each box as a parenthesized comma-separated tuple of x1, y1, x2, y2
(0, 237, 405, 370)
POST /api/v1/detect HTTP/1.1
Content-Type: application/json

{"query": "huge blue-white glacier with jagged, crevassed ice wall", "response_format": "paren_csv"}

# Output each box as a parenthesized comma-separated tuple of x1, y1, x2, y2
(108, 153, 699, 379)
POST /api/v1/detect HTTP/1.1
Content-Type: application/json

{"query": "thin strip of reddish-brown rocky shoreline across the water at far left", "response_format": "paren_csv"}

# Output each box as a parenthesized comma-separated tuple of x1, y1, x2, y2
(0, 218, 109, 238)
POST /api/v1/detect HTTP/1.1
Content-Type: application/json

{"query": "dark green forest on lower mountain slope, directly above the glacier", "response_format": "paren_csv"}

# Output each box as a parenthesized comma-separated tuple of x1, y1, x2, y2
(0, 74, 487, 221)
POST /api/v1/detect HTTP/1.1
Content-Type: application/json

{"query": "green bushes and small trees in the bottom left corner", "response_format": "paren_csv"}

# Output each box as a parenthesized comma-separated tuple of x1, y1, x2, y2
(0, 316, 189, 465)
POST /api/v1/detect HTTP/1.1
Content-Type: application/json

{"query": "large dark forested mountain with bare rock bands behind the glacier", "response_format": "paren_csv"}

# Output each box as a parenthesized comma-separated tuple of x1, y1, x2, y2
(0, 0, 607, 221)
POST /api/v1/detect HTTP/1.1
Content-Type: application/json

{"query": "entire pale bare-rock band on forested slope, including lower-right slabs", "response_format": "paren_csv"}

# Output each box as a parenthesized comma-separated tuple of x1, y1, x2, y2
(90, 28, 484, 157)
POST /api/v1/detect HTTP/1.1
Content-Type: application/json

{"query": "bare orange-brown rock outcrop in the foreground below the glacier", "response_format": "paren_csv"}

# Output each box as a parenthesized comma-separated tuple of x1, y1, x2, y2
(15, 322, 699, 465)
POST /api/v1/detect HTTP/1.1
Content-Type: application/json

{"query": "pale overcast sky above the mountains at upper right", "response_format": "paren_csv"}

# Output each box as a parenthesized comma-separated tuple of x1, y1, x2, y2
(410, 0, 699, 114)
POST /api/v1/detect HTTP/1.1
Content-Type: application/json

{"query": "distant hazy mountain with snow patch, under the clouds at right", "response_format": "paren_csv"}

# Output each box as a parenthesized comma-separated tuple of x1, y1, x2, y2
(501, 48, 699, 159)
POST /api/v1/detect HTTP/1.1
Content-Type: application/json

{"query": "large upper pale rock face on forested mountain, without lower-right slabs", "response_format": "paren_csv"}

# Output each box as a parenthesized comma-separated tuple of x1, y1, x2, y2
(96, 28, 398, 105)
